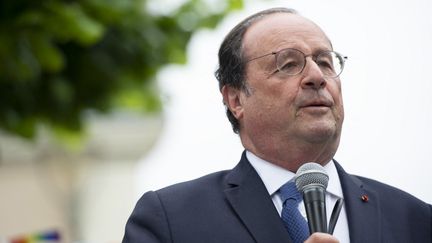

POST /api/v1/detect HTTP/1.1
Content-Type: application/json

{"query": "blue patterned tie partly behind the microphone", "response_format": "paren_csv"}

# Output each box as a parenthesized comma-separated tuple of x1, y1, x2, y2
(280, 181, 309, 243)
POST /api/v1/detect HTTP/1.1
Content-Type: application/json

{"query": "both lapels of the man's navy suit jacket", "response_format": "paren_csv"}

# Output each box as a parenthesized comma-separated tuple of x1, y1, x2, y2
(225, 153, 382, 243)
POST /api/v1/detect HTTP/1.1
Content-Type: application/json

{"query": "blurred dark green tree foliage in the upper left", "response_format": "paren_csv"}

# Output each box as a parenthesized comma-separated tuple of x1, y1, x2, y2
(0, 0, 243, 138)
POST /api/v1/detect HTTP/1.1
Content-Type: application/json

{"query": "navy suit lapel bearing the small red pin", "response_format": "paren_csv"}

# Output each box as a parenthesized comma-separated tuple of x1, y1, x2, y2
(335, 161, 382, 243)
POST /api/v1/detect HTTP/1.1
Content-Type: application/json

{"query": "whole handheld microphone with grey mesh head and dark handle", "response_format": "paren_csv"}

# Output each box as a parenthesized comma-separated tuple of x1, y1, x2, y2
(295, 162, 329, 234)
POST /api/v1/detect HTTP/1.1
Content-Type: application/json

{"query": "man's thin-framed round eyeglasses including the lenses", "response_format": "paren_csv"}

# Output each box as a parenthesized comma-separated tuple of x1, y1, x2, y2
(246, 48, 348, 78)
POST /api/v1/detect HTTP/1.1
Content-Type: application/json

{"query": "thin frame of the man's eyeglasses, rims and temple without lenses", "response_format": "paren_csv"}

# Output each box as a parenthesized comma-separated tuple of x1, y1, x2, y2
(244, 48, 348, 78)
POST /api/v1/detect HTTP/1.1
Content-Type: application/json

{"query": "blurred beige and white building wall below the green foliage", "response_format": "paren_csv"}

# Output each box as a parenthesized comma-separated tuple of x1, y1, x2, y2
(0, 113, 163, 243)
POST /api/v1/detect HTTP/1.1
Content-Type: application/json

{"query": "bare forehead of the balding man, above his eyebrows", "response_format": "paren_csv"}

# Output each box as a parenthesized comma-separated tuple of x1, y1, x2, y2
(242, 13, 332, 57)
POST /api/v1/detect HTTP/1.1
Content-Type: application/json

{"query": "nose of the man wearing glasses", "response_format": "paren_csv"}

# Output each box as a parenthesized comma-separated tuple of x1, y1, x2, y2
(301, 57, 327, 90)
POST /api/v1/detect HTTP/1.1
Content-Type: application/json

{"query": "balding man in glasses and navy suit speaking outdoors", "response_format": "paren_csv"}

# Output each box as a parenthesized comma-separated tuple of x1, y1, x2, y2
(123, 8, 432, 243)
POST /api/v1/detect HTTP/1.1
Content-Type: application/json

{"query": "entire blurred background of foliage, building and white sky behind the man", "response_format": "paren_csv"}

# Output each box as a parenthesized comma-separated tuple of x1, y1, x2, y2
(0, 0, 432, 243)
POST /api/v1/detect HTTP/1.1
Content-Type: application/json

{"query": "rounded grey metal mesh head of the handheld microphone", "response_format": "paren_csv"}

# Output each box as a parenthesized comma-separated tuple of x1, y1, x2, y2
(295, 162, 329, 192)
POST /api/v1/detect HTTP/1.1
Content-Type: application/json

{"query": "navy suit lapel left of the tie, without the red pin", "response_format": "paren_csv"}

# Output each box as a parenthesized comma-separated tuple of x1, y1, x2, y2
(225, 153, 291, 243)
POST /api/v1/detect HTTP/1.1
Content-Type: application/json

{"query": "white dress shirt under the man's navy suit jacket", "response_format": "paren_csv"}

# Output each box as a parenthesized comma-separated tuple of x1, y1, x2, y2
(246, 151, 350, 243)
